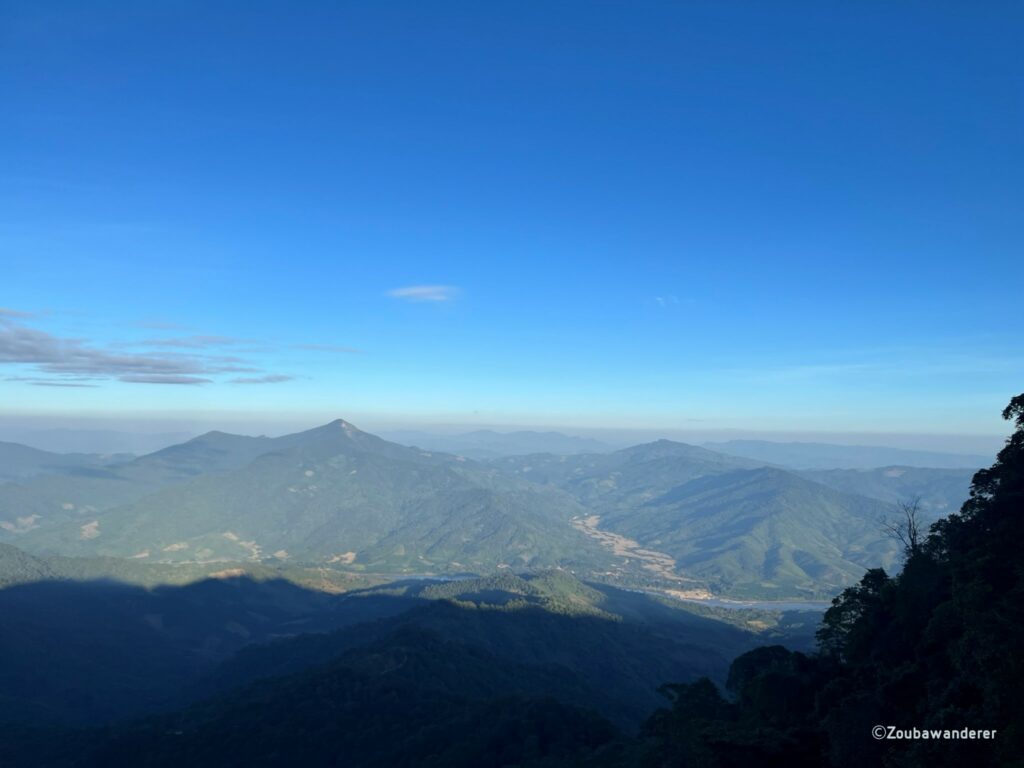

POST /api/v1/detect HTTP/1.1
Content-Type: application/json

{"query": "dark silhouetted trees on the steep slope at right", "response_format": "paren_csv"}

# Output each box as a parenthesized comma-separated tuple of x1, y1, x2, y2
(634, 394, 1024, 768)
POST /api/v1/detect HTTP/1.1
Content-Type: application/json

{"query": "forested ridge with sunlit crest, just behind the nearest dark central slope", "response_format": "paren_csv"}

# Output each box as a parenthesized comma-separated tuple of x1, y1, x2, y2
(199, 571, 761, 726)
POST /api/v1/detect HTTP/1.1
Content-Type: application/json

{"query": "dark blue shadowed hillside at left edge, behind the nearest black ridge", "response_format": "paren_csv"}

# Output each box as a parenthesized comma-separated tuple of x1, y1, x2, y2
(0, 579, 343, 729)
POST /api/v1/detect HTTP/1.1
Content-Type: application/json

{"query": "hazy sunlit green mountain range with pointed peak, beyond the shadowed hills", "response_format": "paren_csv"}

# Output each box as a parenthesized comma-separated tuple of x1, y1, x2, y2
(0, 420, 966, 599)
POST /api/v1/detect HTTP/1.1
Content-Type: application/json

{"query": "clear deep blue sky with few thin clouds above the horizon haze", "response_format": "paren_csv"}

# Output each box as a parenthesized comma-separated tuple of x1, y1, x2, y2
(0, 1, 1024, 433)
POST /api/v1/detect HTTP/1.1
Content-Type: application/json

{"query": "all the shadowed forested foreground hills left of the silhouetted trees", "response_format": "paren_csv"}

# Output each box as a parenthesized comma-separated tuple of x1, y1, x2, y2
(0, 570, 815, 768)
